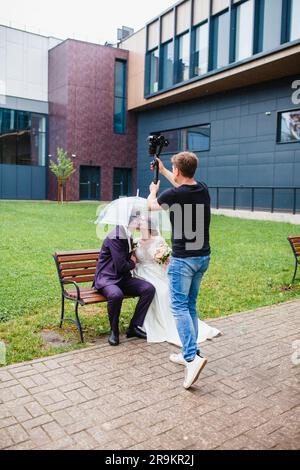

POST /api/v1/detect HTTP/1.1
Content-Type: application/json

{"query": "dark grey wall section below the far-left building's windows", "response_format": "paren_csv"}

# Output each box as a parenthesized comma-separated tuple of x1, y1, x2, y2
(0, 165, 46, 200)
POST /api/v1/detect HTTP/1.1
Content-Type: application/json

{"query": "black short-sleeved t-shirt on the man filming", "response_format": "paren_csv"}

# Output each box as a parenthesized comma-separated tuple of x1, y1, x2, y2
(157, 182, 211, 258)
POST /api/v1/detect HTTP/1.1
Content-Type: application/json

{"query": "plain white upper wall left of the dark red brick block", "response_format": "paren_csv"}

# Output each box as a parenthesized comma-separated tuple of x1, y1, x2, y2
(0, 26, 61, 101)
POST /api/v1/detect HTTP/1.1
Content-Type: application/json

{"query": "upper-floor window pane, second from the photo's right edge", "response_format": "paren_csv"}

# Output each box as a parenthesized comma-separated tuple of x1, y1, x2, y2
(259, 0, 282, 51)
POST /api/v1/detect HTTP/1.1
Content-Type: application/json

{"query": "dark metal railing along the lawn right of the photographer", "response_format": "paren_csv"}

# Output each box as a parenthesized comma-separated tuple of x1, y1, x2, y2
(209, 186, 300, 214)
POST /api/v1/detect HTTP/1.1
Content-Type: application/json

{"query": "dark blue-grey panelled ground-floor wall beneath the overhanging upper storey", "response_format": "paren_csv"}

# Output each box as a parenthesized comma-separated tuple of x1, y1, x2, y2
(138, 77, 300, 210)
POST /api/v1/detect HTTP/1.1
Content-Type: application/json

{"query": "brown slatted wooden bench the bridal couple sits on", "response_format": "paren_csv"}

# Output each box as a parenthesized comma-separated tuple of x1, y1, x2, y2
(53, 250, 137, 343)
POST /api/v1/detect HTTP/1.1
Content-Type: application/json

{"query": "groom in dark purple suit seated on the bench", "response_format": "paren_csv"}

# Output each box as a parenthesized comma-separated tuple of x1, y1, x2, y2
(93, 215, 155, 346)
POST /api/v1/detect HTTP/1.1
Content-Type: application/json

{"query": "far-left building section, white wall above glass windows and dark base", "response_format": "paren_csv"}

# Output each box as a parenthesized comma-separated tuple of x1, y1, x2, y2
(0, 26, 60, 199)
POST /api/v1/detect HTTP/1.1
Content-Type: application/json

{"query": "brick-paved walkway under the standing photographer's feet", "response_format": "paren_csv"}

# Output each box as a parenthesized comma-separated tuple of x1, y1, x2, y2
(0, 302, 300, 450)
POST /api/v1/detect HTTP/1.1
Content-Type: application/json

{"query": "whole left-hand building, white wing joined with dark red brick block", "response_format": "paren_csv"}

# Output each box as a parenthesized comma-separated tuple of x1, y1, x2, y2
(0, 26, 137, 201)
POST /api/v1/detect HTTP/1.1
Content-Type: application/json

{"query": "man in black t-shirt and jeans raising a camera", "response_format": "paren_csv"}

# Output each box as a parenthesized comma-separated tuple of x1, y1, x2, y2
(148, 152, 211, 389)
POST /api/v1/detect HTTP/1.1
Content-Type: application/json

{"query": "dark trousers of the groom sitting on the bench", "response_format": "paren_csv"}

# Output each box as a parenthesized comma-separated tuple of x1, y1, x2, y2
(100, 278, 155, 333)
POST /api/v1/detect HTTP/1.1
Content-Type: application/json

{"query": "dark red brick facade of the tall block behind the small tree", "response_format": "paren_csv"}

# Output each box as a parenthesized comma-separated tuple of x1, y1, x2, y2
(49, 40, 136, 201)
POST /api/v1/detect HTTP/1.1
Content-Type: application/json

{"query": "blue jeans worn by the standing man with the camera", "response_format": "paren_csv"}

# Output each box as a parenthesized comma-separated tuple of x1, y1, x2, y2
(168, 256, 210, 361)
